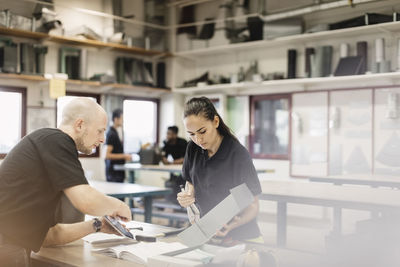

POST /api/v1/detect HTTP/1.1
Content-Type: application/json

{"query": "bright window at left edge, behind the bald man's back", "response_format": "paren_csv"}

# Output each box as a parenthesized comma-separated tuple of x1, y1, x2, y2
(0, 87, 26, 158)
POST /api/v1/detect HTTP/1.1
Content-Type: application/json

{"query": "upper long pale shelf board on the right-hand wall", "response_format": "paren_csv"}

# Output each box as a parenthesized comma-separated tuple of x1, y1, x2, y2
(174, 21, 400, 57)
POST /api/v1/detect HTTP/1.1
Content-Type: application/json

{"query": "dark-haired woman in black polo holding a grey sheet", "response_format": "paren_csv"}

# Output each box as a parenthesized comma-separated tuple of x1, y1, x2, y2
(177, 97, 263, 242)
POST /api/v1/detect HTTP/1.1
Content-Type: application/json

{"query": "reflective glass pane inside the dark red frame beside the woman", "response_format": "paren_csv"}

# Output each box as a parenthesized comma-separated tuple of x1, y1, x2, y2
(253, 99, 289, 155)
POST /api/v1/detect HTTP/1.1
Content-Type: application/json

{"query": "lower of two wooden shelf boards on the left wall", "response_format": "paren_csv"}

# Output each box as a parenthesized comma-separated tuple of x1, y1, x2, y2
(0, 73, 171, 97)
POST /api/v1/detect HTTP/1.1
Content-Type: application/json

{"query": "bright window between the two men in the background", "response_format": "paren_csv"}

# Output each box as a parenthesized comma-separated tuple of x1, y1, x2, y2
(123, 99, 158, 153)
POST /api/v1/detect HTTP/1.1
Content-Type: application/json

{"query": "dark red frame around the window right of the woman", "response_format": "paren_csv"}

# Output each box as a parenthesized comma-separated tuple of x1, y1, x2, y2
(249, 94, 292, 160)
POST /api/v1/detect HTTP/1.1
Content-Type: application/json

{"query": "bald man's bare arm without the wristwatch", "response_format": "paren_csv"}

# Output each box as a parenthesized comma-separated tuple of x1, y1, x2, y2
(64, 184, 132, 221)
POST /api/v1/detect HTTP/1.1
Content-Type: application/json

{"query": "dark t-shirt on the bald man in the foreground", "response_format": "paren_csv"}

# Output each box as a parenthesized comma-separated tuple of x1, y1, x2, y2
(0, 128, 87, 251)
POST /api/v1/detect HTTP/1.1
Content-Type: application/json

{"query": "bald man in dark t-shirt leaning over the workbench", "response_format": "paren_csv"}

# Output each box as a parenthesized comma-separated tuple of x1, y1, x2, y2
(0, 98, 131, 258)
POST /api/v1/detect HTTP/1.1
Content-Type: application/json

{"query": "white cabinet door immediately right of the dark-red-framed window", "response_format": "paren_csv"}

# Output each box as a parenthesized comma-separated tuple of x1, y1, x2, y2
(291, 92, 328, 177)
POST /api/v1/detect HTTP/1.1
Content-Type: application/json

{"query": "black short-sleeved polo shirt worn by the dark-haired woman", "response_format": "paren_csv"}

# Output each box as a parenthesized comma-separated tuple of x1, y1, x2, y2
(182, 136, 261, 240)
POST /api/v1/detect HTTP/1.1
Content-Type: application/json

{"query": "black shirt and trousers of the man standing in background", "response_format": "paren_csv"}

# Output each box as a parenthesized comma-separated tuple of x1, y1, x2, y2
(106, 127, 125, 183)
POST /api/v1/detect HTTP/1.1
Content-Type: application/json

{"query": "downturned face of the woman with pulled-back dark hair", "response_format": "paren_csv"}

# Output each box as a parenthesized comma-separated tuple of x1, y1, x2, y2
(183, 115, 219, 149)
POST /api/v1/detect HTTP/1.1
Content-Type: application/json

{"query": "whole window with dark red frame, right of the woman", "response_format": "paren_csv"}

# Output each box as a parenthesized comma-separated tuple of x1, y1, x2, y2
(250, 95, 290, 159)
